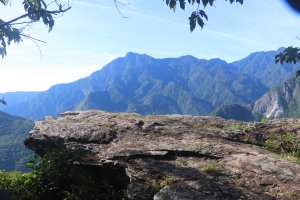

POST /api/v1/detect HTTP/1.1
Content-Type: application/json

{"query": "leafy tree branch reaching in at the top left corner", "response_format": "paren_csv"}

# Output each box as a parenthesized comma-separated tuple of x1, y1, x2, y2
(0, 0, 71, 58)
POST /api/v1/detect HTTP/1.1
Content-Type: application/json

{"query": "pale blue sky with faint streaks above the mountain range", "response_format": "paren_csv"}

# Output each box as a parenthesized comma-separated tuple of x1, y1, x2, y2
(0, 0, 300, 92)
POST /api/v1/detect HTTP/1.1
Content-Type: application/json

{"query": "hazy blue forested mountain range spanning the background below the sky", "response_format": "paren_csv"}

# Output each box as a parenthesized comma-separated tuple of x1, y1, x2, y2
(0, 49, 298, 120)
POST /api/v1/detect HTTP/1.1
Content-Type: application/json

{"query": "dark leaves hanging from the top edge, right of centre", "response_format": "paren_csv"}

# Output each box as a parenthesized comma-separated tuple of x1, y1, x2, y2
(166, 0, 244, 32)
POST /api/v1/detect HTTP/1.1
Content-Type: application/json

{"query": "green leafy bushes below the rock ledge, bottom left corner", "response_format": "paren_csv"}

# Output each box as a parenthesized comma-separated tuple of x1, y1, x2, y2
(0, 149, 122, 200)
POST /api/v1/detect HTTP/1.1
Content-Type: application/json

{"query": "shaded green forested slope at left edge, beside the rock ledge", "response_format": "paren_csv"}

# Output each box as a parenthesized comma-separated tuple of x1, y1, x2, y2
(0, 112, 34, 171)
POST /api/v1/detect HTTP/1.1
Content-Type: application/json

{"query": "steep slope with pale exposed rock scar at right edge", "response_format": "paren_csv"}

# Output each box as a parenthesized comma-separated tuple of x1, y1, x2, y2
(253, 78, 300, 118)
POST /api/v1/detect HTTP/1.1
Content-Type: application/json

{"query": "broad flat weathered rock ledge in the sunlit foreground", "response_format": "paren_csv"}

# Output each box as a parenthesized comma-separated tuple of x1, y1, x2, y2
(25, 111, 300, 200)
